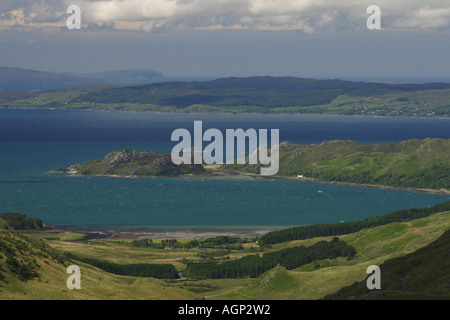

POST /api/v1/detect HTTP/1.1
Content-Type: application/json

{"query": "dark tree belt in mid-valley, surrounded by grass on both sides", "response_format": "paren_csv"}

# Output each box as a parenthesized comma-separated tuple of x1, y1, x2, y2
(183, 238, 356, 279)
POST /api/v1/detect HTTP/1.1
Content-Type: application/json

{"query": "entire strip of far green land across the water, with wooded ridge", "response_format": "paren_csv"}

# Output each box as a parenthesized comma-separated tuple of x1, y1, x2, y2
(0, 77, 450, 116)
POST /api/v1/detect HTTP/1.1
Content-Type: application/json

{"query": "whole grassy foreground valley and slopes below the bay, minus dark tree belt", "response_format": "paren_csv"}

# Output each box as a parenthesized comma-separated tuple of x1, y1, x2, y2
(0, 202, 450, 300)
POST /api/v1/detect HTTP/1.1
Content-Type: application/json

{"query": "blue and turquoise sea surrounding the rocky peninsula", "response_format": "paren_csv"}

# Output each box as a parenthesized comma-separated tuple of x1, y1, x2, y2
(0, 109, 450, 230)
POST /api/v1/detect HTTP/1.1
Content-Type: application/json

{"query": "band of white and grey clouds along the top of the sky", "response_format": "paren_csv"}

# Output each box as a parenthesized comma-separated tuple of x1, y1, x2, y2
(0, 0, 450, 33)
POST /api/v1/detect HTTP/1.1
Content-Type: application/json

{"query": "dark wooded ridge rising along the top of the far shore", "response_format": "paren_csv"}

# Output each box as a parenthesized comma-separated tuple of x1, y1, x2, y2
(68, 77, 450, 109)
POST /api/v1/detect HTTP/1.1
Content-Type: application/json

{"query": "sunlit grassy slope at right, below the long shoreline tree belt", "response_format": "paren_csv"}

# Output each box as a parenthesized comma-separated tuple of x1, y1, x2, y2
(204, 212, 450, 300)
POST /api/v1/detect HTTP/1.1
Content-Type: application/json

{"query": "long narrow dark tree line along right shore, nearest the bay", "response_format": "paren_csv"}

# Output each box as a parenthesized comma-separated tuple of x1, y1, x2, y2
(259, 201, 450, 246)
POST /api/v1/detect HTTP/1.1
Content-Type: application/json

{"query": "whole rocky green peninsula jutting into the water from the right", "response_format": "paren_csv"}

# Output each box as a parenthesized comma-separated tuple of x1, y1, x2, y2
(51, 139, 450, 193)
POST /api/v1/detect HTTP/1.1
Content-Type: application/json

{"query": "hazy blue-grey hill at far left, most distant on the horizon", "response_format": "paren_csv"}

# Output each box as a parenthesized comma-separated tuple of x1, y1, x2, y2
(0, 67, 163, 91)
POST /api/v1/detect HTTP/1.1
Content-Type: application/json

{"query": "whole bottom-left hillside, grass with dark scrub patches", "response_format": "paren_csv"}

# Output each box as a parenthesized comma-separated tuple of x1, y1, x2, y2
(0, 219, 197, 300)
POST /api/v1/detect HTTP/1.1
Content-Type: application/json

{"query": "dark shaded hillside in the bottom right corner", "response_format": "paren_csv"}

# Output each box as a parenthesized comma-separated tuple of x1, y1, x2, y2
(324, 230, 450, 300)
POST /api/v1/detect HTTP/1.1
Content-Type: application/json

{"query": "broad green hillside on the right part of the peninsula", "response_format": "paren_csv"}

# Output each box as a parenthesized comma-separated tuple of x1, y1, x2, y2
(224, 139, 450, 190)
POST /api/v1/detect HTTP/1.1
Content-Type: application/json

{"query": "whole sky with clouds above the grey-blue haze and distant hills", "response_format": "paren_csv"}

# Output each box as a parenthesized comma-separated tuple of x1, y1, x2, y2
(0, 0, 450, 81)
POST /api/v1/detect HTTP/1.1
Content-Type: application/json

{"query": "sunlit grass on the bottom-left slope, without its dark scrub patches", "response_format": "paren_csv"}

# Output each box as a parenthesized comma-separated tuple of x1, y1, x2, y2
(0, 220, 197, 300)
